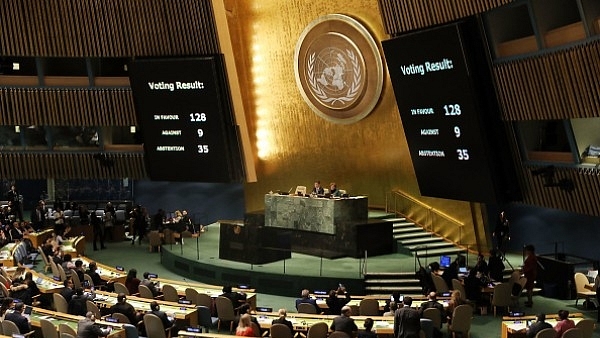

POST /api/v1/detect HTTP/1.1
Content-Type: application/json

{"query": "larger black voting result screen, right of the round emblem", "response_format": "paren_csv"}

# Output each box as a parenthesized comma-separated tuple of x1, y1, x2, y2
(383, 17, 503, 202)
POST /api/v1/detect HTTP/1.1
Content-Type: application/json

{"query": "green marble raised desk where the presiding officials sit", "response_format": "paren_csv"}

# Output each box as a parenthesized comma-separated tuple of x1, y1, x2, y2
(265, 194, 368, 235)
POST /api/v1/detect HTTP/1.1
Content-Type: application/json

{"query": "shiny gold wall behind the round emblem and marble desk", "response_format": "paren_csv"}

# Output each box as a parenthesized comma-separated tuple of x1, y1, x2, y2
(220, 0, 487, 249)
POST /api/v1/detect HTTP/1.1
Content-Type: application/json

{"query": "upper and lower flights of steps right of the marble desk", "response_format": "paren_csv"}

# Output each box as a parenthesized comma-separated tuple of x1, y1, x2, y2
(364, 218, 465, 295)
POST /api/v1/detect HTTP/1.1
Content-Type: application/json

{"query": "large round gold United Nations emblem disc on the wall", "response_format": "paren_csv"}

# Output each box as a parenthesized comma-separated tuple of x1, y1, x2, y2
(294, 14, 383, 123)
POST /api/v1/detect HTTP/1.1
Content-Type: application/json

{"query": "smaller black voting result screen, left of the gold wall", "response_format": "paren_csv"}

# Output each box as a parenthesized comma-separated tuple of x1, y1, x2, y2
(130, 55, 243, 182)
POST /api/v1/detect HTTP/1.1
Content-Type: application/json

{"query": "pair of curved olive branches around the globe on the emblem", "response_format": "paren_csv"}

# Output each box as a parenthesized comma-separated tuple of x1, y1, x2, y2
(307, 49, 362, 105)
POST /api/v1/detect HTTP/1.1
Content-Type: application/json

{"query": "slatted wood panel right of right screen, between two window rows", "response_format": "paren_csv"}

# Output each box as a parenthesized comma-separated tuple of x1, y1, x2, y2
(494, 40, 600, 121)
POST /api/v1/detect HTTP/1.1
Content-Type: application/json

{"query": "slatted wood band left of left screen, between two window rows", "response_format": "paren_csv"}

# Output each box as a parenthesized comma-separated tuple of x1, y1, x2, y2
(0, 88, 137, 126)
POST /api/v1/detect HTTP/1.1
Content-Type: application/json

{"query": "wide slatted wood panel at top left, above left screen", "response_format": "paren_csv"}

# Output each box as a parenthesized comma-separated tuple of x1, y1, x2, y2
(0, 0, 219, 57)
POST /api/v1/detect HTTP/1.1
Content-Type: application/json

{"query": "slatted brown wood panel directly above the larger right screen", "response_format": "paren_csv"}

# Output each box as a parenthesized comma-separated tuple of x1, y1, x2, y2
(379, 0, 513, 35)
